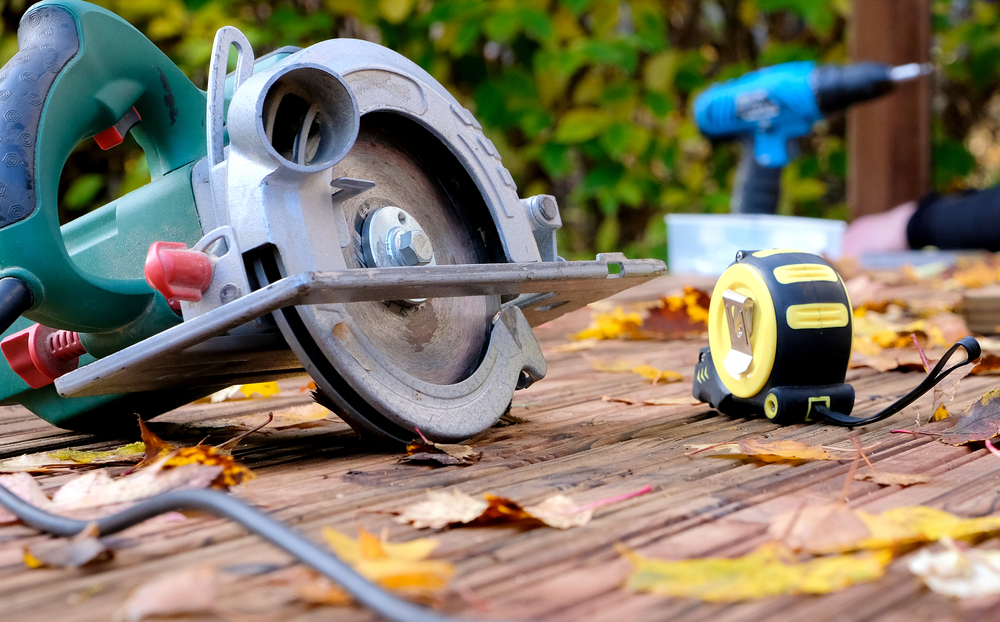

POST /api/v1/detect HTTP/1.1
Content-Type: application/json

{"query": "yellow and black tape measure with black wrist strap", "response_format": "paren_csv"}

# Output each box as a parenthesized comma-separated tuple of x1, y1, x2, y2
(692, 250, 980, 426)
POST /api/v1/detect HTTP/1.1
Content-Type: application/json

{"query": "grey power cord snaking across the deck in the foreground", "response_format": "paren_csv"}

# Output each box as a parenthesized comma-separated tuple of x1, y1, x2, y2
(0, 485, 504, 622)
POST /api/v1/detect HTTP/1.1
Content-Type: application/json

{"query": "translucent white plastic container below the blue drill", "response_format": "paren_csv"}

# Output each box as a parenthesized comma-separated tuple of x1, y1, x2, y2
(666, 214, 847, 276)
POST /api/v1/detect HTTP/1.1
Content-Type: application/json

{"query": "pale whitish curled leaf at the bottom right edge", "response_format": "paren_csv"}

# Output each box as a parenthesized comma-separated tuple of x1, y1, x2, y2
(908, 537, 1000, 598)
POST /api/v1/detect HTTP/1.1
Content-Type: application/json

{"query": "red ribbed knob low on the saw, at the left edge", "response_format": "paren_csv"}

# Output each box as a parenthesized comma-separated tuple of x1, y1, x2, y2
(0, 324, 87, 389)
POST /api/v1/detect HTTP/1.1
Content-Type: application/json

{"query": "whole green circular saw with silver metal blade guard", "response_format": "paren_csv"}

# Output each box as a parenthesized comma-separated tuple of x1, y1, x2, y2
(0, 0, 665, 441)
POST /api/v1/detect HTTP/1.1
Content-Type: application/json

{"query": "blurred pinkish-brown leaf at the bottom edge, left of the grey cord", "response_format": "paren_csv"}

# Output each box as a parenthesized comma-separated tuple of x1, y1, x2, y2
(117, 566, 219, 622)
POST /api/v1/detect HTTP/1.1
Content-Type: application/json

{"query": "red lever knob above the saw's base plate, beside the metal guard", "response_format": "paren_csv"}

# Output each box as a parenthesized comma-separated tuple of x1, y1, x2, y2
(145, 242, 212, 306)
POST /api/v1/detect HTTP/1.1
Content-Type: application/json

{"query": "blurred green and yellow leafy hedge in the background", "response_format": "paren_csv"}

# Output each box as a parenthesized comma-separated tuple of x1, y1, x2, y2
(0, 0, 1000, 258)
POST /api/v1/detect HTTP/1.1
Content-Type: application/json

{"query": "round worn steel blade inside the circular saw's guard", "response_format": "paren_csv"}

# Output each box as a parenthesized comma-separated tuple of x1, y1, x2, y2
(333, 114, 500, 384)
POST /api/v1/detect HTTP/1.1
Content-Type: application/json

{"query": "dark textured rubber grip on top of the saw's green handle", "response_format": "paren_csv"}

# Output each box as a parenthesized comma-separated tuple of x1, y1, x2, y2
(0, 6, 80, 228)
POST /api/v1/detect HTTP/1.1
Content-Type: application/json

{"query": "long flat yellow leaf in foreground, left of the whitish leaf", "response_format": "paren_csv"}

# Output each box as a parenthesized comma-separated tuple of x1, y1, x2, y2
(623, 544, 892, 602)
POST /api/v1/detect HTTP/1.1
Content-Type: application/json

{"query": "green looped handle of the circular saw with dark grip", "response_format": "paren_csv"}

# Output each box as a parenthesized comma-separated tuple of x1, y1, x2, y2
(0, 0, 206, 333)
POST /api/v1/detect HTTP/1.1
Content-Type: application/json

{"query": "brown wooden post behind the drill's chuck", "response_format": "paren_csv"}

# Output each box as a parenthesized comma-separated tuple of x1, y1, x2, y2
(847, 0, 931, 218)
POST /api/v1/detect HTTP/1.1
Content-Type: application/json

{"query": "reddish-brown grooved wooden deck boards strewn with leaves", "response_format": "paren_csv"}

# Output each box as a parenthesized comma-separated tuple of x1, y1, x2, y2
(0, 277, 1000, 622)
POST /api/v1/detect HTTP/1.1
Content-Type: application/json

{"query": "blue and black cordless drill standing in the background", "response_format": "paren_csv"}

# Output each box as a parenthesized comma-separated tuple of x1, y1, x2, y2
(694, 61, 933, 214)
